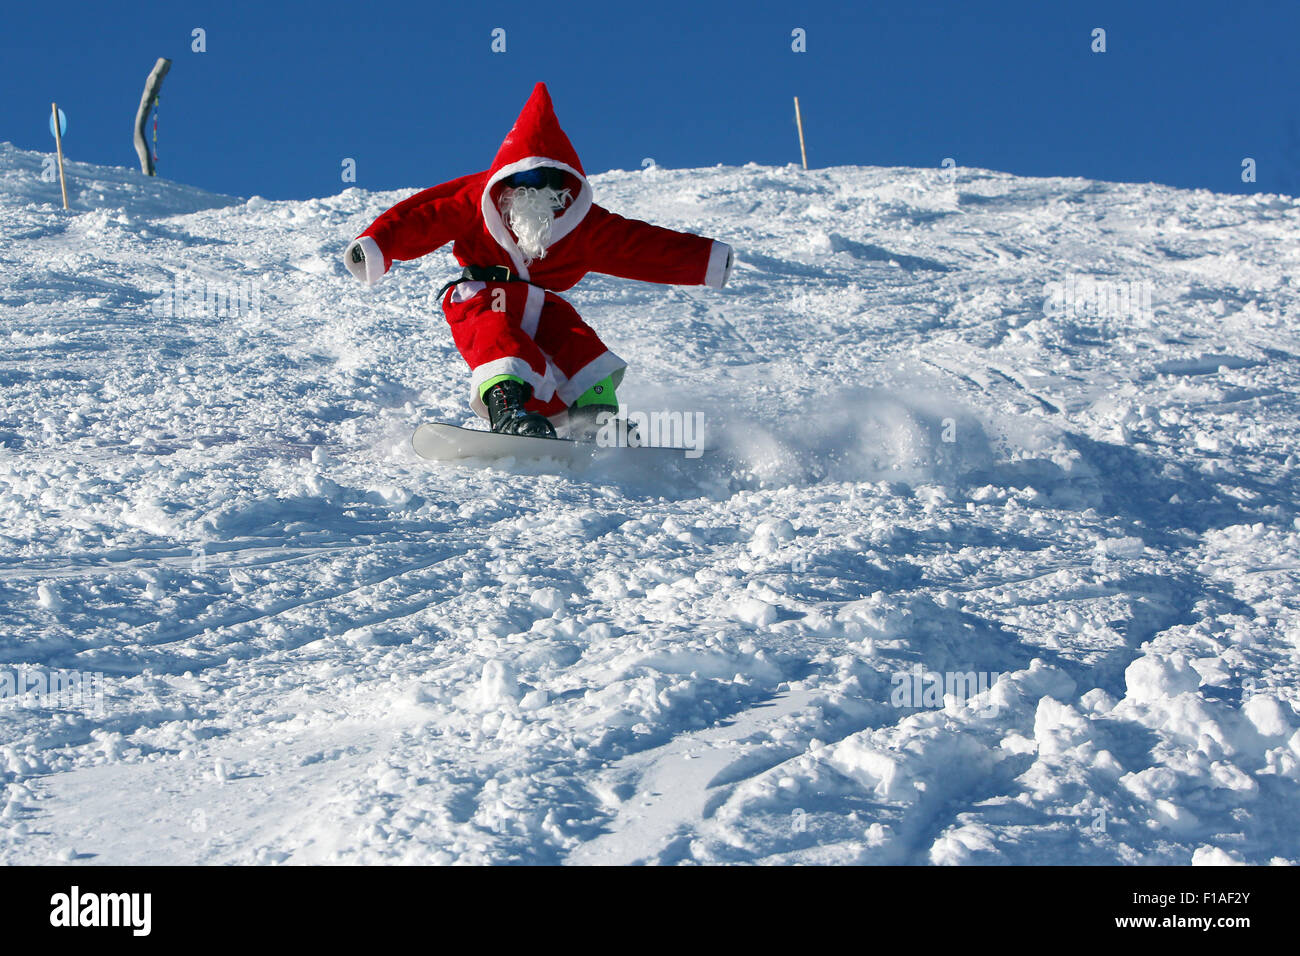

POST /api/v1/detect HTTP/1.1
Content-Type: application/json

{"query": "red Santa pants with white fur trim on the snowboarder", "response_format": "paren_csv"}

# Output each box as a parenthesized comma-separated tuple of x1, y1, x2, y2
(442, 282, 628, 418)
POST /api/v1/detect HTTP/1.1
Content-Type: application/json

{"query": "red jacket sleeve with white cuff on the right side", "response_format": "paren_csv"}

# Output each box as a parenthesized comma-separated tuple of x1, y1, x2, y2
(582, 206, 731, 287)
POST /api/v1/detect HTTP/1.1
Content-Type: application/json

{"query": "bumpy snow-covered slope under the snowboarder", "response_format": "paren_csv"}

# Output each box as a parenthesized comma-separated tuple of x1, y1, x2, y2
(0, 144, 1300, 864)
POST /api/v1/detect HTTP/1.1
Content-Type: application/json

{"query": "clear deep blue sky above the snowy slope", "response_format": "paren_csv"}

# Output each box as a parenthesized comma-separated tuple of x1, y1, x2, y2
(0, 0, 1300, 199)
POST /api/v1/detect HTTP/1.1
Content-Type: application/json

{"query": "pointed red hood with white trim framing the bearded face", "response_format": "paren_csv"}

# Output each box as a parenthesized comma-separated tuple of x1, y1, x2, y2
(481, 83, 592, 278)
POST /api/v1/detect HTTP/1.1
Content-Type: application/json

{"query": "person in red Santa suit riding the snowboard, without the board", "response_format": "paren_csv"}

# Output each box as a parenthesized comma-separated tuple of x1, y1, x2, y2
(343, 83, 732, 438)
